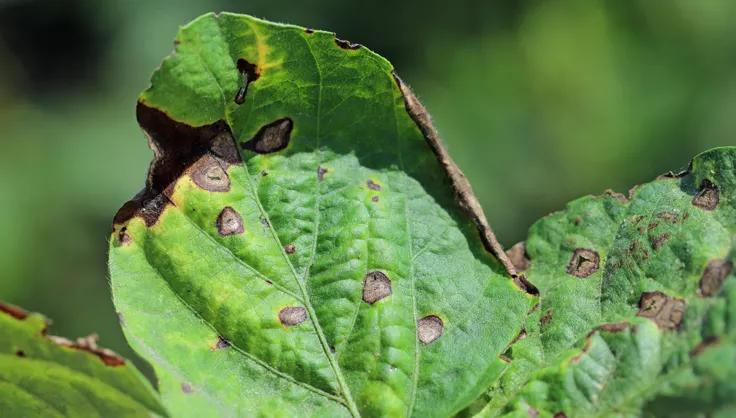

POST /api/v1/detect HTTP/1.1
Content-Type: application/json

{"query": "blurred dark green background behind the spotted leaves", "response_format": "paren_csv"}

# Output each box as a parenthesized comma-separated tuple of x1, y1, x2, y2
(0, 0, 736, 372)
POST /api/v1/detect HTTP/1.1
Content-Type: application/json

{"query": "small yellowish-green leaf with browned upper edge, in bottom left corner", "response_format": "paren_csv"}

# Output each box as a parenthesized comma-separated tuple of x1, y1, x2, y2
(0, 303, 166, 417)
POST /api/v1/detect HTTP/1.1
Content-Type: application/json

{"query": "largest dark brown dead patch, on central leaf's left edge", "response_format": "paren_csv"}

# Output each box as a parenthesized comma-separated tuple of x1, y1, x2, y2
(113, 102, 240, 226)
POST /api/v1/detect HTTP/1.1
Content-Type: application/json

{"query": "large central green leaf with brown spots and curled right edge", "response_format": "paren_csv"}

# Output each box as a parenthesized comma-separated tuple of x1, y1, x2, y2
(110, 14, 535, 417)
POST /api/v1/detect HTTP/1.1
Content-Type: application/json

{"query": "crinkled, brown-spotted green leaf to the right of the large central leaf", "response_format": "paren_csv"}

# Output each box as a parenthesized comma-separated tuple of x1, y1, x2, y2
(479, 148, 736, 417)
